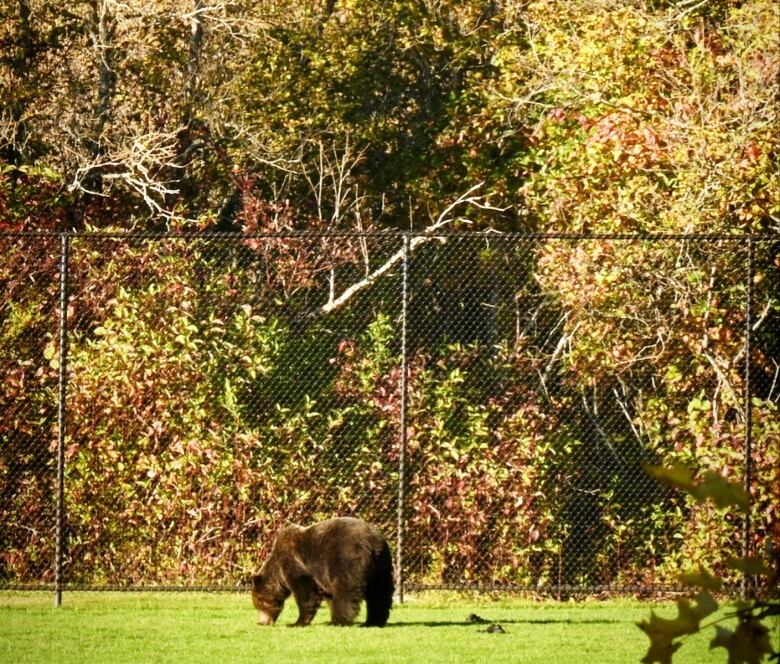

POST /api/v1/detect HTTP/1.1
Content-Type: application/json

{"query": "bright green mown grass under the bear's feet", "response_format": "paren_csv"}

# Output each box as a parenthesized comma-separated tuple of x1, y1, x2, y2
(0, 592, 777, 664)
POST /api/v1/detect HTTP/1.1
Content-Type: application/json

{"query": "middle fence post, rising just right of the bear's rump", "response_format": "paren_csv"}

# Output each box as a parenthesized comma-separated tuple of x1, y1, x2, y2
(396, 233, 410, 604)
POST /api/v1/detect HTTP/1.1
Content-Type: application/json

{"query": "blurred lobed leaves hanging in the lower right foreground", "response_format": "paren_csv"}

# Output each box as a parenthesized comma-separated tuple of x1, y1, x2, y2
(637, 464, 780, 664)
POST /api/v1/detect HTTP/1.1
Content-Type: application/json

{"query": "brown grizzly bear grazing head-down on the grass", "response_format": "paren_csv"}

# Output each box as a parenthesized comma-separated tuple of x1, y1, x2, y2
(252, 517, 394, 627)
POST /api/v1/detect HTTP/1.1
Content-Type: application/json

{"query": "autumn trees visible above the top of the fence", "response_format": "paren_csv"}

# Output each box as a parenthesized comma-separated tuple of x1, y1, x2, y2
(0, 0, 780, 239)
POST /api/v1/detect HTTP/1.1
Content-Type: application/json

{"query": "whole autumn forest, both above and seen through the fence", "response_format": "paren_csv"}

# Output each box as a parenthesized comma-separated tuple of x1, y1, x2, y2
(0, 0, 780, 584)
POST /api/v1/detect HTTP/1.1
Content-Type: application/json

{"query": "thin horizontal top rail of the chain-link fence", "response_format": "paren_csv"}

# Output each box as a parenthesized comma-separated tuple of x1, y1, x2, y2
(0, 230, 780, 243)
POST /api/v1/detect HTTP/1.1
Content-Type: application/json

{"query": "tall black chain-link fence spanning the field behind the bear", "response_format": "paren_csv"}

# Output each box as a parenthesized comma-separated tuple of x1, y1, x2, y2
(0, 233, 780, 595)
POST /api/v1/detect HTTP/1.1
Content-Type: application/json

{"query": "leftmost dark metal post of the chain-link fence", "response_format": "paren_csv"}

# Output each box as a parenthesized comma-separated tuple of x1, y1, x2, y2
(54, 232, 70, 607)
